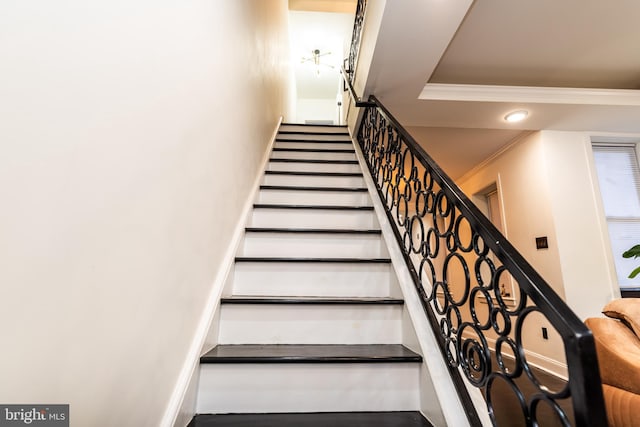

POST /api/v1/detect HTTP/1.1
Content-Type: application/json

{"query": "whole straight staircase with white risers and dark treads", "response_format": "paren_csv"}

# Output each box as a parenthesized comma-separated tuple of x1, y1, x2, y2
(190, 125, 431, 427)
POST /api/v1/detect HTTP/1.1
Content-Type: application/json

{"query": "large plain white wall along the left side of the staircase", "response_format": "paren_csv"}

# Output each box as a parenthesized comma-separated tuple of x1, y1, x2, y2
(0, 0, 288, 426)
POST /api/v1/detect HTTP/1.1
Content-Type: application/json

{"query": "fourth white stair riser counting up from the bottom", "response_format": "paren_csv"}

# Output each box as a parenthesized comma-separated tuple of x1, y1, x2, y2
(238, 232, 388, 258)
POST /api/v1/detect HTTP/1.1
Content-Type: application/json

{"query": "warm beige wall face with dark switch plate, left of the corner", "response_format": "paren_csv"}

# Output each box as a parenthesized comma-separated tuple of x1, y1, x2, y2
(459, 132, 566, 375)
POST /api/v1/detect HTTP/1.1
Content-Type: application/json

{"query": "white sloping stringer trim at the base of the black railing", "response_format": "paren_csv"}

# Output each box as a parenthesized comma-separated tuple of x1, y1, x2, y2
(353, 138, 492, 427)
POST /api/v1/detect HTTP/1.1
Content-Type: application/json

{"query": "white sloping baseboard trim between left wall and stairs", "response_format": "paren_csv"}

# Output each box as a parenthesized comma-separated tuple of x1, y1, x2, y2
(160, 116, 282, 427)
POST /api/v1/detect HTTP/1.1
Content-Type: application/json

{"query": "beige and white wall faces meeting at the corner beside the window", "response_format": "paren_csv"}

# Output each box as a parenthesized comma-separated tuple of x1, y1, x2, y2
(459, 131, 632, 373)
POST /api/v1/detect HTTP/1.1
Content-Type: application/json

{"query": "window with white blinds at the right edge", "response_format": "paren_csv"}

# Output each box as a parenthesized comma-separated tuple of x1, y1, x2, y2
(593, 144, 640, 290)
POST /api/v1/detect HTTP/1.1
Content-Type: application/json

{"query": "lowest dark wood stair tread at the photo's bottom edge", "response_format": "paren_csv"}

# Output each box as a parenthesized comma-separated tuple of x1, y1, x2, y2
(187, 411, 433, 427)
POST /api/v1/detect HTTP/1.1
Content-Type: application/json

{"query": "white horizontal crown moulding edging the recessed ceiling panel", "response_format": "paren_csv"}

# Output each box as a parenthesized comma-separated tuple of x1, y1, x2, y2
(418, 83, 640, 106)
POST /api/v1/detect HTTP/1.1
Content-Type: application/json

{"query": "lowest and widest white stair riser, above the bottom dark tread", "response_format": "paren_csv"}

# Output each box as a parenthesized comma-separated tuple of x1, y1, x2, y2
(196, 363, 420, 413)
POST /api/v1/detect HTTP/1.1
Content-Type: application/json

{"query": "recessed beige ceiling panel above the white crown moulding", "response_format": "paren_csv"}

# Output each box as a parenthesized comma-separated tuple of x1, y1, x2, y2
(430, 0, 640, 89)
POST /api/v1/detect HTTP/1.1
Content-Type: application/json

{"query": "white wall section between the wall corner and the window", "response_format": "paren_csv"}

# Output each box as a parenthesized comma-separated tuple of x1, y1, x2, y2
(542, 131, 620, 320)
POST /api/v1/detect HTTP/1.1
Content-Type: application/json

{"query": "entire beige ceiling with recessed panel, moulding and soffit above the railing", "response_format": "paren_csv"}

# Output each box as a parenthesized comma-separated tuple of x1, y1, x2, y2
(364, 0, 640, 178)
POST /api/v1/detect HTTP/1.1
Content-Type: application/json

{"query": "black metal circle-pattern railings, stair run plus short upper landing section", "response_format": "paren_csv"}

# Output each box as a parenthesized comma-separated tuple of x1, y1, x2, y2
(343, 2, 606, 426)
